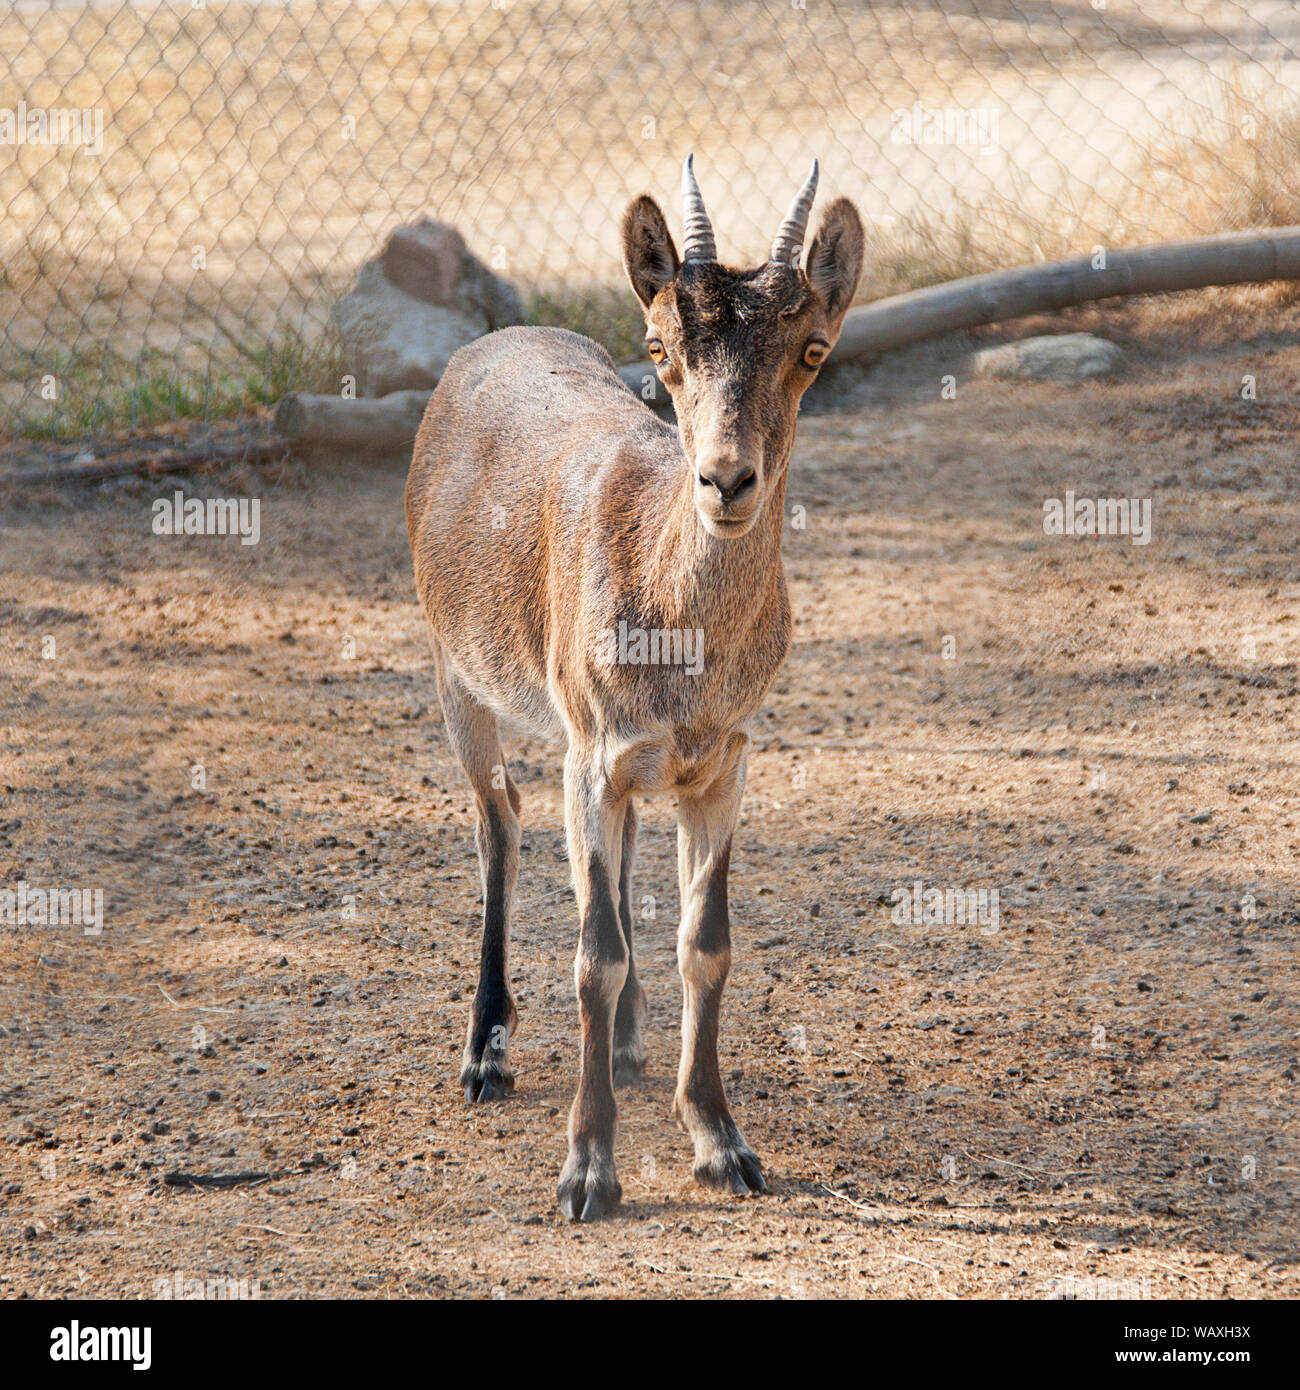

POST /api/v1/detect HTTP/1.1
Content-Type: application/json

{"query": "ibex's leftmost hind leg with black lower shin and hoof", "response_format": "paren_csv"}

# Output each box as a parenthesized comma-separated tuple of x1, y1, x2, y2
(437, 651, 520, 1102)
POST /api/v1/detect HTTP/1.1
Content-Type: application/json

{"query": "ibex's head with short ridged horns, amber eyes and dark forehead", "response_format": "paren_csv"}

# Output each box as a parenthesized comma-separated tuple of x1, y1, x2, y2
(623, 156, 863, 538)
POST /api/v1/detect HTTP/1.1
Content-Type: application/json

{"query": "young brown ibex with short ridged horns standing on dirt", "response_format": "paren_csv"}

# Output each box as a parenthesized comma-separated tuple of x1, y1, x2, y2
(406, 158, 863, 1220)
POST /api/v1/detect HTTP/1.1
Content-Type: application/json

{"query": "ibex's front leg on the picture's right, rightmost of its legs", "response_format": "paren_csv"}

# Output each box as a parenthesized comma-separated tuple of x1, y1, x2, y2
(673, 741, 767, 1194)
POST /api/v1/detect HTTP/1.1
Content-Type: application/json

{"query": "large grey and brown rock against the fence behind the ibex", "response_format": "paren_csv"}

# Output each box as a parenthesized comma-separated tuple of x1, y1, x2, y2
(334, 218, 524, 396)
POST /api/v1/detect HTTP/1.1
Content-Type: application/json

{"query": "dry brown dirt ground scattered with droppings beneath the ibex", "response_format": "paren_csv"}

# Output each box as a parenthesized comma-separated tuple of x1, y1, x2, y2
(0, 309, 1300, 1298)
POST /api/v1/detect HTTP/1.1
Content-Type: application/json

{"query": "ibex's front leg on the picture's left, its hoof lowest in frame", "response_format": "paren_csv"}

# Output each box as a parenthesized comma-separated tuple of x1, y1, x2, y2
(559, 746, 628, 1220)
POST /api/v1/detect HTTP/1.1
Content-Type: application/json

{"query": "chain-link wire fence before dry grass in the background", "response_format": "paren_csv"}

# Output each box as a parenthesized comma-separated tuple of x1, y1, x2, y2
(0, 0, 1300, 434)
